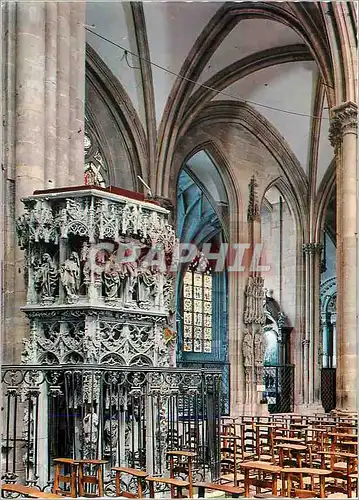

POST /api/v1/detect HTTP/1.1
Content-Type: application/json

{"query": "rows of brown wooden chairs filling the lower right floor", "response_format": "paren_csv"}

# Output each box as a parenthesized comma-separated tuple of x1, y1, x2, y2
(220, 415, 358, 497)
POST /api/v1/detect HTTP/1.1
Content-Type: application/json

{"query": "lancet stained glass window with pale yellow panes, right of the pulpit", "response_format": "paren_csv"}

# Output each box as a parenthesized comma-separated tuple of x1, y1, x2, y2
(183, 255, 212, 353)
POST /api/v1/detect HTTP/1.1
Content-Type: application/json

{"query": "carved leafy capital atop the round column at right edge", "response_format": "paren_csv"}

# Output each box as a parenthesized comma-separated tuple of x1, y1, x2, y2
(329, 101, 358, 149)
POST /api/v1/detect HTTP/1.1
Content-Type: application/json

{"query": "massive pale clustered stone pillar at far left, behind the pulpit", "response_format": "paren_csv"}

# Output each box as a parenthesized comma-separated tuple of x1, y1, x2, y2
(2, 2, 85, 363)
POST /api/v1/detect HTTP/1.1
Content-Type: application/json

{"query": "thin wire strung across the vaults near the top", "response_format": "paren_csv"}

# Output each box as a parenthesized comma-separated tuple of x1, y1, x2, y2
(85, 26, 329, 120)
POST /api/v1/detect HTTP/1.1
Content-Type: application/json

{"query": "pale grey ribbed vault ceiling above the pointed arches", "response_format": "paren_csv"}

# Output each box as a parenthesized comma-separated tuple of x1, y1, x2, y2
(86, 2, 333, 188)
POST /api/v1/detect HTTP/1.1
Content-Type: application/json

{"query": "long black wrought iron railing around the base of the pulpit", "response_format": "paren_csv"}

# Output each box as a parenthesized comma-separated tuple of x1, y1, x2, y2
(2, 365, 221, 495)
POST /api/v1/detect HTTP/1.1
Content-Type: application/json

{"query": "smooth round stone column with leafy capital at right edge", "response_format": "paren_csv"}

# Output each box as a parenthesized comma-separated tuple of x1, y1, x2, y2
(329, 101, 358, 411)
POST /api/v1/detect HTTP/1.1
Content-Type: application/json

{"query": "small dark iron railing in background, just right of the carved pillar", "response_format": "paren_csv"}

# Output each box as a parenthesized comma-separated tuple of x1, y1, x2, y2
(263, 365, 294, 413)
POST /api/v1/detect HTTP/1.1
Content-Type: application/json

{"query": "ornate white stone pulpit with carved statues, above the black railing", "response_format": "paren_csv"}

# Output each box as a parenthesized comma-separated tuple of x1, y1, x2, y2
(17, 186, 176, 367)
